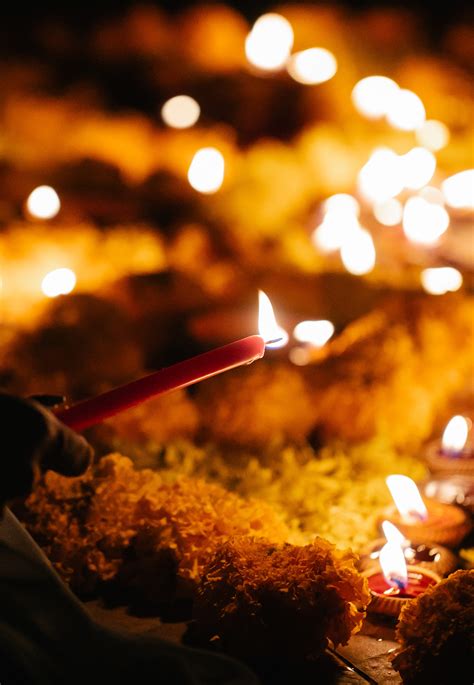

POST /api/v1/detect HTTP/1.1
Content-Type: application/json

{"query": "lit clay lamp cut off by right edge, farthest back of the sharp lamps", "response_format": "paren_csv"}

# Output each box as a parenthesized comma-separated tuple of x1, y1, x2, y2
(425, 415, 474, 476)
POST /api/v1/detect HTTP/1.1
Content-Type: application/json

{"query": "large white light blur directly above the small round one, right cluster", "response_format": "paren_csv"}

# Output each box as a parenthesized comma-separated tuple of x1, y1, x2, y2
(358, 148, 404, 202)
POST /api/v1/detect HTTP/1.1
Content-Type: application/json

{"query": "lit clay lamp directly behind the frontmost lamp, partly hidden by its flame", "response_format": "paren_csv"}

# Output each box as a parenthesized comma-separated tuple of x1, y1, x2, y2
(360, 520, 457, 576)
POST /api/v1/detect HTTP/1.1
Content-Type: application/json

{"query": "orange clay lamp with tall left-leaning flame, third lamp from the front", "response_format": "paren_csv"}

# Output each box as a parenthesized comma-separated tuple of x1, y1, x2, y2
(384, 475, 471, 547)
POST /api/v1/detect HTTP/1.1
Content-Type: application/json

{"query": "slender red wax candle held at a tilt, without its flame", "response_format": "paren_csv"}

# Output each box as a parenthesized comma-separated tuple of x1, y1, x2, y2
(56, 335, 265, 431)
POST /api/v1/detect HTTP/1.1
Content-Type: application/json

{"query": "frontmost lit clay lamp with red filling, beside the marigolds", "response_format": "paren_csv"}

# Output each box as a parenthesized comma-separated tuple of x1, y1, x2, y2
(363, 540, 441, 617)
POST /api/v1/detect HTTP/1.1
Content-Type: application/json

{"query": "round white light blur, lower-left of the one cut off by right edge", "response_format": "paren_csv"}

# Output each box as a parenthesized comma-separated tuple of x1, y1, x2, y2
(403, 197, 449, 245)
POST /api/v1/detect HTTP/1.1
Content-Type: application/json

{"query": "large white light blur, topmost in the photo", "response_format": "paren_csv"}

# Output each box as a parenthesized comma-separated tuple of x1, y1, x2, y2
(245, 12, 293, 71)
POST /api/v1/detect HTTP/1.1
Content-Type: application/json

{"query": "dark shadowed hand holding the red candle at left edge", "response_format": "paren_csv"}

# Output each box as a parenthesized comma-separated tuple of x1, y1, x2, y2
(0, 393, 92, 510)
